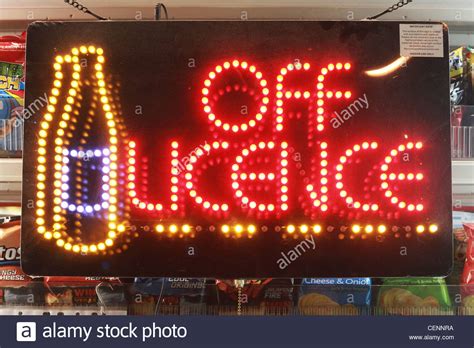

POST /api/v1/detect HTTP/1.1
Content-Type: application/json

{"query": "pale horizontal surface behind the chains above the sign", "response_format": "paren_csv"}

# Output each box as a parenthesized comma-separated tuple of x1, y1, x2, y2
(0, 0, 474, 46)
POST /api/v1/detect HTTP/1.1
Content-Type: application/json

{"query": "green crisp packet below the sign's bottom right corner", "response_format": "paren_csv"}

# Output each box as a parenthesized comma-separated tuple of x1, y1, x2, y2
(377, 278, 452, 315)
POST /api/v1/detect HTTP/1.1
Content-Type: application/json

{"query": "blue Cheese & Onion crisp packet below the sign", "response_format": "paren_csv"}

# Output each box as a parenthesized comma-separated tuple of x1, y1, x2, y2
(298, 278, 371, 315)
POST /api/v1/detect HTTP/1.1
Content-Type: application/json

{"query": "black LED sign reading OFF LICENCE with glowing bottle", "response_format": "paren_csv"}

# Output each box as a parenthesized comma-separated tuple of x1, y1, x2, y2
(22, 21, 452, 278)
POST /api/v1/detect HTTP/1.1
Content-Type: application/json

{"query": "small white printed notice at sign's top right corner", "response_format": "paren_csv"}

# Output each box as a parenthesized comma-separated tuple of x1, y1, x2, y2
(400, 24, 443, 57)
